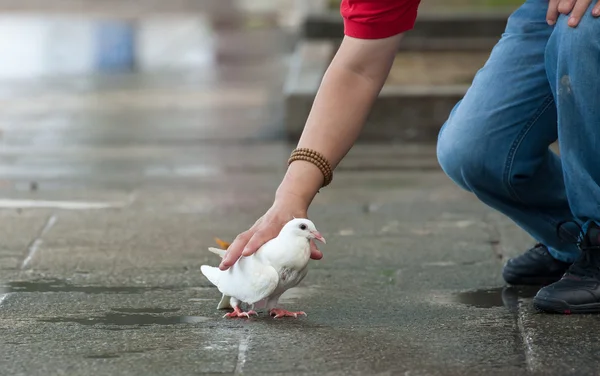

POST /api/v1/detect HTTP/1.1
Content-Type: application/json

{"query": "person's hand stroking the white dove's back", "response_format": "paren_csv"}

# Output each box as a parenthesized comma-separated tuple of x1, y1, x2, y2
(219, 197, 323, 270)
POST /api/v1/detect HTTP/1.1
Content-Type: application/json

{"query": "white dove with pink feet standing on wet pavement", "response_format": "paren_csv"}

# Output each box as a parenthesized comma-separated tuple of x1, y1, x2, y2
(200, 218, 325, 318)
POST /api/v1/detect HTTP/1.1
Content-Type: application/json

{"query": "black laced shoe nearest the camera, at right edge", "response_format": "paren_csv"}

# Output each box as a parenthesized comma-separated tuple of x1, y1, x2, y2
(533, 224, 600, 314)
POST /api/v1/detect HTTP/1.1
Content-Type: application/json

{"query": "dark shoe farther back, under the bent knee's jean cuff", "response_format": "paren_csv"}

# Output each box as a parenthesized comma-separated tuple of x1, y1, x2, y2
(502, 244, 571, 286)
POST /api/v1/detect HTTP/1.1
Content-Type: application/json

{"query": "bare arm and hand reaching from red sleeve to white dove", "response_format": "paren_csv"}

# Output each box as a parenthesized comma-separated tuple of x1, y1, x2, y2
(221, 34, 402, 269)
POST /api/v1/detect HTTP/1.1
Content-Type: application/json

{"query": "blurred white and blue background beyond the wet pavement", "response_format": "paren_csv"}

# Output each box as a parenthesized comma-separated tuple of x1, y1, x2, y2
(0, 0, 519, 80)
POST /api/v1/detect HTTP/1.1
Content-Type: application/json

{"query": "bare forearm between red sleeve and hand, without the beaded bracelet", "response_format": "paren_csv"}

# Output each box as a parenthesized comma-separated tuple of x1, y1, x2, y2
(277, 36, 400, 206)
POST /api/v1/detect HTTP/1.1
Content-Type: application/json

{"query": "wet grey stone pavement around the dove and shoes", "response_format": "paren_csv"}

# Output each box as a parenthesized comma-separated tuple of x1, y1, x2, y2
(0, 27, 600, 376)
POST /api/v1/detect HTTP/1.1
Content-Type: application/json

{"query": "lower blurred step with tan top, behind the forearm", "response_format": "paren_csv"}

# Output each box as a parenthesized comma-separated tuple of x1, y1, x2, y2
(285, 40, 489, 142)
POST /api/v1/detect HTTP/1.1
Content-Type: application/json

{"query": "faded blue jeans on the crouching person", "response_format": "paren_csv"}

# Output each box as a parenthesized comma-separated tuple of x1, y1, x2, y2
(437, 0, 600, 262)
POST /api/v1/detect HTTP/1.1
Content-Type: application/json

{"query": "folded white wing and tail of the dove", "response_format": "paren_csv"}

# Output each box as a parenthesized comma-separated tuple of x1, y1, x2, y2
(200, 256, 279, 304)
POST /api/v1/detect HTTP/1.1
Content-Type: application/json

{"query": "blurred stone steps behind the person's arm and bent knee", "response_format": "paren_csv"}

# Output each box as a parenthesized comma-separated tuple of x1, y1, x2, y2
(285, 9, 512, 142)
